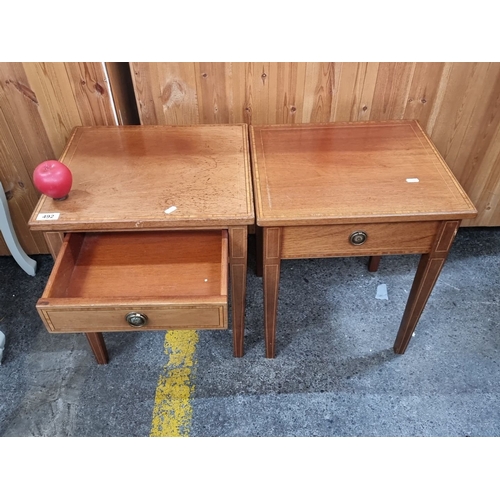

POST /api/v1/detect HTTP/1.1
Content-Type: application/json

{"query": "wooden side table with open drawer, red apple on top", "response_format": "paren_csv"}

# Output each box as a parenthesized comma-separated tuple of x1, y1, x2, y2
(29, 124, 254, 364)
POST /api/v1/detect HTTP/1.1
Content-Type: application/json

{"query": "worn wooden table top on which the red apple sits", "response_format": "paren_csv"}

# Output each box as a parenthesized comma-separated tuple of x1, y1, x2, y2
(29, 124, 255, 231)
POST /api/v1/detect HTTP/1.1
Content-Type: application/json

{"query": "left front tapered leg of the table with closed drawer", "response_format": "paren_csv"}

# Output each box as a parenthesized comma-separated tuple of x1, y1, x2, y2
(262, 227, 281, 358)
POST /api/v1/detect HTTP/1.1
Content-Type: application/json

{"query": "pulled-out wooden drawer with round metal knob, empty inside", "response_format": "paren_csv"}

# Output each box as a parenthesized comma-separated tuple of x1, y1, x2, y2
(36, 230, 228, 333)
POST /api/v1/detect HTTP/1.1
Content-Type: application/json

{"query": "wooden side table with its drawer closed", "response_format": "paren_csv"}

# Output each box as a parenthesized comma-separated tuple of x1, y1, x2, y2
(250, 121, 477, 358)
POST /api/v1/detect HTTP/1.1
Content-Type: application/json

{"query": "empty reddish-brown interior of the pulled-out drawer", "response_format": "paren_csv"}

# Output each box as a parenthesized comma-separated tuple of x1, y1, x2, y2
(43, 230, 228, 300)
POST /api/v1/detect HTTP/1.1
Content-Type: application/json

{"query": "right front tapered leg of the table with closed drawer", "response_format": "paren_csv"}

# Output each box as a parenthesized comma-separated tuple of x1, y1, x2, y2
(394, 221, 460, 354)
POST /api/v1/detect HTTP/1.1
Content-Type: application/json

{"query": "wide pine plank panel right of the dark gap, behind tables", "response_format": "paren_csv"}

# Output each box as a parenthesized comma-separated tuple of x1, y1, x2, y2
(131, 62, 500, 226)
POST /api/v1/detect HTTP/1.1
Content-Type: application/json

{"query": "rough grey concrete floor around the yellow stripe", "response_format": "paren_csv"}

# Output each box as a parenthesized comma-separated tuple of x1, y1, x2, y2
(0, 228, 500, 437)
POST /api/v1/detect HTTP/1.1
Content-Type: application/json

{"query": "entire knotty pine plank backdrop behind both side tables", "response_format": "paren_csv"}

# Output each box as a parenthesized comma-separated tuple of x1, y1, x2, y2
(0, 62, 500, 255)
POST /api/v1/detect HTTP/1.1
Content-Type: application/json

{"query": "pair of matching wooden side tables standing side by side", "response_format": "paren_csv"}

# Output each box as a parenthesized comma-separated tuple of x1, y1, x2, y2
(29, 120, 477, 364)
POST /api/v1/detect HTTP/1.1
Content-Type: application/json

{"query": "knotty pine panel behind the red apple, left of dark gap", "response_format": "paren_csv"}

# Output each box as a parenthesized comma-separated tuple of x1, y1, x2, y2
(0, 62, 120, 255)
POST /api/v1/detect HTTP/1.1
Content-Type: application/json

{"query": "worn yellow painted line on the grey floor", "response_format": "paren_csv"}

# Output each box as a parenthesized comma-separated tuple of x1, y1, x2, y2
(150, 330, 198, 437)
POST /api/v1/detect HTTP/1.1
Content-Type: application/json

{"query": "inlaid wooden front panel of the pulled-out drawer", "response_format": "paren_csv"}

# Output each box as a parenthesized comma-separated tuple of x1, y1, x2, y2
(37, 303, 227, 333)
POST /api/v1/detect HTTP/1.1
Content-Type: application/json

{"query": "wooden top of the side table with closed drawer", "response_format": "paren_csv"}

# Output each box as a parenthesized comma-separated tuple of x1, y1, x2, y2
(250, 120, 477, 226)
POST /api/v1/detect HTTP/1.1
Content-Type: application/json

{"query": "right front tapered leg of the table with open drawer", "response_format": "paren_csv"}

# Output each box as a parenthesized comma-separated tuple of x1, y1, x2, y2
(229, 226, 248, 358)
